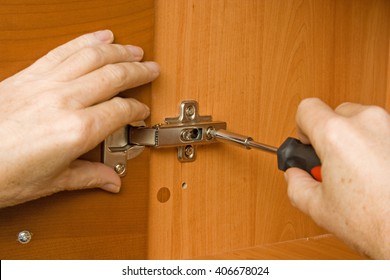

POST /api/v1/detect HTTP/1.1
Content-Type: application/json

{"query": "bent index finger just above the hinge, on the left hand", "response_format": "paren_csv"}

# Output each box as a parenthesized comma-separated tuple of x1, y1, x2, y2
(83, 97, 150, 151)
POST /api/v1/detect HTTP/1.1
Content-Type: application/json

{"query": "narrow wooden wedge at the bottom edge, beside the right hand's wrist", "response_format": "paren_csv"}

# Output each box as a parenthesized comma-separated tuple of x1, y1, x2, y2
(200, 234, 366, 260)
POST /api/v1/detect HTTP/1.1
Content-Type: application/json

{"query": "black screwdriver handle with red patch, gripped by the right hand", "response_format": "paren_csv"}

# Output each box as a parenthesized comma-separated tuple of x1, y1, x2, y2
(277, 137, 322, 182)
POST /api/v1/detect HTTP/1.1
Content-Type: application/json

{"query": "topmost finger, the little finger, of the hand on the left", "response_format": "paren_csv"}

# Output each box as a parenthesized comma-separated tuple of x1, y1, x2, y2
(30, 30, 114, 71)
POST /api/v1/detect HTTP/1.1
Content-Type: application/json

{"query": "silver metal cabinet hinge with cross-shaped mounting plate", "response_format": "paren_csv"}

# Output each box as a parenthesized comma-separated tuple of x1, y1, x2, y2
(103, 100, 226, 176)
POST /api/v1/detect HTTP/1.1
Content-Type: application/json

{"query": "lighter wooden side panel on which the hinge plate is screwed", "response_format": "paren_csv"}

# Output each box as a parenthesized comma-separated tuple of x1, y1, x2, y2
(149, 0, 390, 258)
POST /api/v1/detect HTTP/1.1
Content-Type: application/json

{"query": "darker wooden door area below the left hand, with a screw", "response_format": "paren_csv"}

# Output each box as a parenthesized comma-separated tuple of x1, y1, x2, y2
(0, 153, 148, 259)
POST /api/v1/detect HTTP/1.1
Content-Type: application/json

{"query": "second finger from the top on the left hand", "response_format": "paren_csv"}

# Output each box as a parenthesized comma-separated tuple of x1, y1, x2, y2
(53, 44, 144, 81)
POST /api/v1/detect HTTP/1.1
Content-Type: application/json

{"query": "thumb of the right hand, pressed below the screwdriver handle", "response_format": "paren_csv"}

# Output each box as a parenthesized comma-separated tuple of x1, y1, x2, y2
(285, 168, 322, 219)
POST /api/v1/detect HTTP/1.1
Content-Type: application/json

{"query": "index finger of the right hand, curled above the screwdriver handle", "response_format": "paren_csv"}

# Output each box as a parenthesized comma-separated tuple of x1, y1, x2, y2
(296, 98, 336, 153)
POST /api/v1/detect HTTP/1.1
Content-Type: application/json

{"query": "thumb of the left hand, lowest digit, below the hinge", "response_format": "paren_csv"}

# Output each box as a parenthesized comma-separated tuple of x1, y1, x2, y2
(56, 160, 121, 193)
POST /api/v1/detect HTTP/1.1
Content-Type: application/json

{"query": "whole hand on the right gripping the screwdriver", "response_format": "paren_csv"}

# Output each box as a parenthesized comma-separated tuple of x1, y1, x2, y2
(286, 99, 390, 258)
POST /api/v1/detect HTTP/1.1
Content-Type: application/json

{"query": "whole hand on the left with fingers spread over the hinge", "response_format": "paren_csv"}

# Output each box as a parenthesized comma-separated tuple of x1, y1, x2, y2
(0, 30, 159, 207)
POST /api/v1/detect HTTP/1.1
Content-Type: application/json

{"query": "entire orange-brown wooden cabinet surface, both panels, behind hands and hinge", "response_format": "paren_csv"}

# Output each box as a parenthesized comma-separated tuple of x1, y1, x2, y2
(0, 0, 390, 259)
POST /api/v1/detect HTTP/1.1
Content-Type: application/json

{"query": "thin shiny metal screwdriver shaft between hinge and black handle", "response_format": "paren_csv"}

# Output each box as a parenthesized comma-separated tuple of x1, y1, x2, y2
(210, 129, 278, 154)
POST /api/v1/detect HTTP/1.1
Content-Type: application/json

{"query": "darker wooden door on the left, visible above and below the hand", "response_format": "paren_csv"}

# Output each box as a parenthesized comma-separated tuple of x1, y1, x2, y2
(0, 0, 154, 259)
